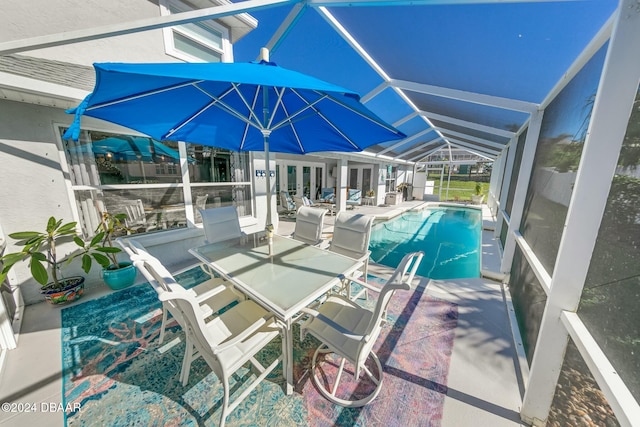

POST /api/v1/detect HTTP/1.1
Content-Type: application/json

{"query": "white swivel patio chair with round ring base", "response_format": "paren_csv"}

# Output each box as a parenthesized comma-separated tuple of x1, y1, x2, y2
(300, 252, 424, 407)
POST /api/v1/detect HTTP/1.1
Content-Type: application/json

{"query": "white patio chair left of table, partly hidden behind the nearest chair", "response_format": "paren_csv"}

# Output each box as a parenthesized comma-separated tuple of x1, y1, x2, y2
(116, 238, 245, 385)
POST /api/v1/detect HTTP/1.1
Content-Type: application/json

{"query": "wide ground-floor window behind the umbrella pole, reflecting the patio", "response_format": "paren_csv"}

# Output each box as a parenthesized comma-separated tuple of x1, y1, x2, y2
(60, 128, 252, 236)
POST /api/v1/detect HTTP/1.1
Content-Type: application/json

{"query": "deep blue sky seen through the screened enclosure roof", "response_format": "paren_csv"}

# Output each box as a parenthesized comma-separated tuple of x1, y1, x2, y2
(229, 0, 617, 152)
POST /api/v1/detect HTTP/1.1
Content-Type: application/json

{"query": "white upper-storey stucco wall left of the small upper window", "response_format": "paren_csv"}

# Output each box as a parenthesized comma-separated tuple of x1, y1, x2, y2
(0, 0, 176, 65)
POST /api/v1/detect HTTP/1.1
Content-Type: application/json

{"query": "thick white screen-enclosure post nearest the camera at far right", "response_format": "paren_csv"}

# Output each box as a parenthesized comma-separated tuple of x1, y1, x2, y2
(521, 0, 640, 425)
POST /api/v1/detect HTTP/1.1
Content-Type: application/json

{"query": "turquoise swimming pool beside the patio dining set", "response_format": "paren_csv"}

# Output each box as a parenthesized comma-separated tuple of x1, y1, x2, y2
(369, 206, 482, 279)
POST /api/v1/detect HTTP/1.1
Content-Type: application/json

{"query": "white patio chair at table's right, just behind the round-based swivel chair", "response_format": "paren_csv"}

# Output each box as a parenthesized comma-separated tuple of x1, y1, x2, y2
(329, 211, 374, 299)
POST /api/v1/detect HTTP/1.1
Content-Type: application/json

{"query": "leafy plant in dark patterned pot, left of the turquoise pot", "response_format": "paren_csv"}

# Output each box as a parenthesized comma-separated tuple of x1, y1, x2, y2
(0, 217, 90, 304)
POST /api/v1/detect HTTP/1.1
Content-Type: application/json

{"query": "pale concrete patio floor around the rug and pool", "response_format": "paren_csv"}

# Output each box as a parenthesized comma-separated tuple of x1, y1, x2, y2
(0, 201, 524, 427)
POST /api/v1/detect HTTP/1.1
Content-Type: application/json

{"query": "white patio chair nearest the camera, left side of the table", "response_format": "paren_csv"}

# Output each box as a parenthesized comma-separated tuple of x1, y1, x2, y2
(160, 289, 286, 426)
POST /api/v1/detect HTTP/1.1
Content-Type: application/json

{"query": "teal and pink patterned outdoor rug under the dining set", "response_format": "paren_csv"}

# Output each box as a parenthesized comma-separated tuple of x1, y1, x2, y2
(62, 269, 458, 426)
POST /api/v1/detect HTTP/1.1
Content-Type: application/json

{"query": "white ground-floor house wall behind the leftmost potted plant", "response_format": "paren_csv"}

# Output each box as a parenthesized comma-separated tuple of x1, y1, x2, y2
(0, 101, 95, 304)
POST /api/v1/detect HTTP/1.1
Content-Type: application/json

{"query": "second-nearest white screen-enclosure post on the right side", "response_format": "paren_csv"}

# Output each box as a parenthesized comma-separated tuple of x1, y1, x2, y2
(500, 111, 543, 273)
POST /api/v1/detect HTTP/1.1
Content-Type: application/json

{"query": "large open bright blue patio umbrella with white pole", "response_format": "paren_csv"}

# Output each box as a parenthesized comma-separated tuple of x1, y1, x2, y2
(65, 61, 406, 226)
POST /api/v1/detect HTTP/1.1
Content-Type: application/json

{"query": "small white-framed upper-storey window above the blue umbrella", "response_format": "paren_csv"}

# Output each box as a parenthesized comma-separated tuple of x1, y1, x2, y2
(160, 0, 230, 62)
